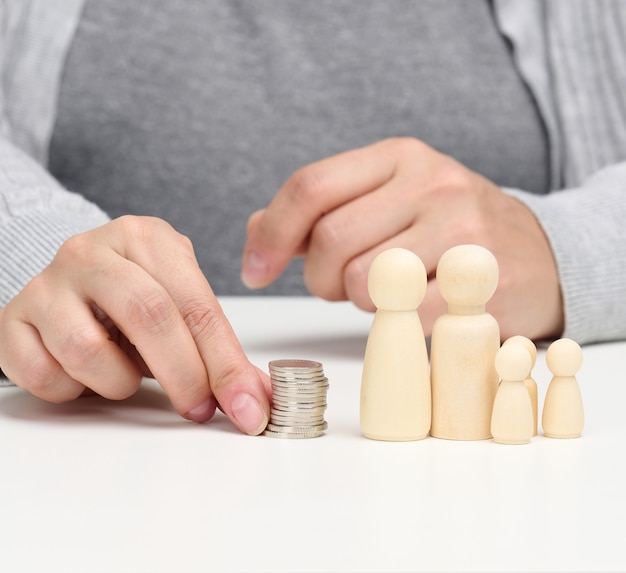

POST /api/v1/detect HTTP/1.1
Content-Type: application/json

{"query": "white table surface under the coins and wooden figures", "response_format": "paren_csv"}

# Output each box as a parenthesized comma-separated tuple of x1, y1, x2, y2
(0, 298, 626, 573)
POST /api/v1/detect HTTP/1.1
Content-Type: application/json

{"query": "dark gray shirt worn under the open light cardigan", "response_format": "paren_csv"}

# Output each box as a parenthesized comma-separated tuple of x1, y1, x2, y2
(49, 0, 549, 295)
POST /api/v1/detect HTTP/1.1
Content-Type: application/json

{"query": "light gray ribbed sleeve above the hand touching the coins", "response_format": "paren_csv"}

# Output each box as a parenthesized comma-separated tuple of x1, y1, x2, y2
(0, 138, 108, 307)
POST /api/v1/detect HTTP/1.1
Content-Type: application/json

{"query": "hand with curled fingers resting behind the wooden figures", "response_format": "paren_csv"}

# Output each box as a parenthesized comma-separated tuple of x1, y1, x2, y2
(242, 138, 563, 339)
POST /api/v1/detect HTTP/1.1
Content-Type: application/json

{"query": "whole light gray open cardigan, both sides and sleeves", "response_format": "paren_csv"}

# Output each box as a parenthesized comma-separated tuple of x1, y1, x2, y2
(0, 0, 626, 342)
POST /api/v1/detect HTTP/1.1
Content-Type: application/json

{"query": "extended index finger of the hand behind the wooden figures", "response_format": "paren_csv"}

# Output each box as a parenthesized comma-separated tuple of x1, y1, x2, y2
(241, 141, 396, 288)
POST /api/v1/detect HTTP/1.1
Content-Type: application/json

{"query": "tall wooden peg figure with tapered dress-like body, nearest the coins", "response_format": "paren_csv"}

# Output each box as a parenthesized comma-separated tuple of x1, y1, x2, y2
(361, 248, 431, 441)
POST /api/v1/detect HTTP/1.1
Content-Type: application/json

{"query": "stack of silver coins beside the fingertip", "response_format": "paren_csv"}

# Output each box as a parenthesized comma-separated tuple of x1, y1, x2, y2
(264, 360, 328, 438)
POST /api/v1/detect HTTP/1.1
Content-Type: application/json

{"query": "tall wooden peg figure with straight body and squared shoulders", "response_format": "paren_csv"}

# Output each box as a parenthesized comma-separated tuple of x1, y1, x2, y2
(430, 245, 500, 440)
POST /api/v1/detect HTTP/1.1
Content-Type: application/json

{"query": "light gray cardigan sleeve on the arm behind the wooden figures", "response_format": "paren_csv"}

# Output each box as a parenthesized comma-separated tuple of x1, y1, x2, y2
(505, 162, 626, 344)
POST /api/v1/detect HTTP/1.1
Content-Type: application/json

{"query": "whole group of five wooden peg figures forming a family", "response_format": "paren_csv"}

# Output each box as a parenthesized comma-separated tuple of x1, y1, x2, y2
(361, 245, 584, 444)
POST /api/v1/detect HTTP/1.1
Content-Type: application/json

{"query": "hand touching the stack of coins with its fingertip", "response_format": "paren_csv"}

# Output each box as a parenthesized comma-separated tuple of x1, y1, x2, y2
(0, 216, 270, 434)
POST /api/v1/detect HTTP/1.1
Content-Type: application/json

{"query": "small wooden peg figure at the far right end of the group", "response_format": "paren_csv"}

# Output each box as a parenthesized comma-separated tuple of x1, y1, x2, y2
(541, 338, 585, 438)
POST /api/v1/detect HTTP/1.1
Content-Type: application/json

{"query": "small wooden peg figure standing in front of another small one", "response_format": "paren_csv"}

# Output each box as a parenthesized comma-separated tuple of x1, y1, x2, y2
(491, 343, 533, 444)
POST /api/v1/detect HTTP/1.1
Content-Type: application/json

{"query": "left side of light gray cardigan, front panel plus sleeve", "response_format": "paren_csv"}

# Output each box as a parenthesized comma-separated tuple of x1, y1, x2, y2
(0, 0, 102, 307)
